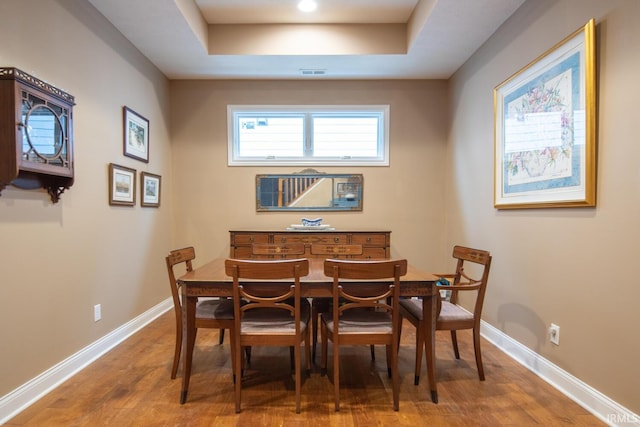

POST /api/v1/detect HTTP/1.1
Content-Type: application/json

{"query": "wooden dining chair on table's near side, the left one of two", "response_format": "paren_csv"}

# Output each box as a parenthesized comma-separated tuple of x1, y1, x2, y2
(225, 259, 311, 413)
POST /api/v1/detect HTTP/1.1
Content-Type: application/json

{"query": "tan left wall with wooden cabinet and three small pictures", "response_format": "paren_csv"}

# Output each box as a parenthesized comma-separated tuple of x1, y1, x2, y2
(0, 0, 172, 396)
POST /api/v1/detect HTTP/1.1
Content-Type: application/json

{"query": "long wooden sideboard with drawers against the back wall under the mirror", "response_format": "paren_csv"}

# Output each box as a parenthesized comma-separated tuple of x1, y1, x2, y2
(229, 230, 391, 259)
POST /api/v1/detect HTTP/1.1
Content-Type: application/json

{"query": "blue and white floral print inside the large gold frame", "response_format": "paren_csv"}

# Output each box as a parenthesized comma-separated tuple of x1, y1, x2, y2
(503, 51, 584, 193)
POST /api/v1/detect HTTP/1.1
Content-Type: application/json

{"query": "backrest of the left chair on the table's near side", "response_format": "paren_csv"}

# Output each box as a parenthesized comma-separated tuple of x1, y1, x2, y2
(225, 259, 309, 335)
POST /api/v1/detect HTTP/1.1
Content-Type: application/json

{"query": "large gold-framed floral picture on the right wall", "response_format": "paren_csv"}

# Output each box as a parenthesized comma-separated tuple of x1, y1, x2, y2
(494, 19, 596, 209)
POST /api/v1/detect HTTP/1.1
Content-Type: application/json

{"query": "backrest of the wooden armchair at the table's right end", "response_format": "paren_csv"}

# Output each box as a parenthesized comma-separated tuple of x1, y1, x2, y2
(445, 246, 491, 315)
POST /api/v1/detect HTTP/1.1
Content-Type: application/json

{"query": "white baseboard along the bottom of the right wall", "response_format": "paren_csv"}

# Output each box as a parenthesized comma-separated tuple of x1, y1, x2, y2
(480, 322, 640, 426)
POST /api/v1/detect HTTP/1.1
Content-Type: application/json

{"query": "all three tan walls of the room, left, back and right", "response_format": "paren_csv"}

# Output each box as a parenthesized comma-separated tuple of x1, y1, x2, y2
(0, 0, 640, 413)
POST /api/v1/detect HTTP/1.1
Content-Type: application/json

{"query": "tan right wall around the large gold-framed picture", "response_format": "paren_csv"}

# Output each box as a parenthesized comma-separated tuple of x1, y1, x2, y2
(447, 0, 640, 413)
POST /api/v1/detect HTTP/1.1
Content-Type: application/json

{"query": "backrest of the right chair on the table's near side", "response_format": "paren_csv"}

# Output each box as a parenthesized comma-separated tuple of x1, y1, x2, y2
(324, 259, 407, 328)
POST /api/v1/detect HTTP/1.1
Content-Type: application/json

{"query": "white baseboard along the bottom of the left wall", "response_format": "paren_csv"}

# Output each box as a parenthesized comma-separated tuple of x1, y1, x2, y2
(0, 298, 173, 425)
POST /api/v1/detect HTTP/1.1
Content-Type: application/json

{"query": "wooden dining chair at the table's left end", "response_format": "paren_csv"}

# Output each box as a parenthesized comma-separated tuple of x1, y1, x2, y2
(165, 246, 234, 379)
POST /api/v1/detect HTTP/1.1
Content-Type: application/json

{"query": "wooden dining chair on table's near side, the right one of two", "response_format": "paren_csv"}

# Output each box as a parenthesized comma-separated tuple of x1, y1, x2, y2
(320, 259, 407, 411)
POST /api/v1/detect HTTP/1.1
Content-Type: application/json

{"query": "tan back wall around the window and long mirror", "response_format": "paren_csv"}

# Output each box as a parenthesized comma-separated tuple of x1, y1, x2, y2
(171, 80, 449, 268)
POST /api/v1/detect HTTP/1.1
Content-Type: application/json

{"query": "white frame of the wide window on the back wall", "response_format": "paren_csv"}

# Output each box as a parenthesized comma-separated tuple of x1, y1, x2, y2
(227, 105, 390, 166)
